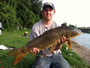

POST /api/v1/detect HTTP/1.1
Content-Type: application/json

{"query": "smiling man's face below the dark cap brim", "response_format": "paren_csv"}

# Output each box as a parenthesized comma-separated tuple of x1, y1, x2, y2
(42, 7, 55, 20)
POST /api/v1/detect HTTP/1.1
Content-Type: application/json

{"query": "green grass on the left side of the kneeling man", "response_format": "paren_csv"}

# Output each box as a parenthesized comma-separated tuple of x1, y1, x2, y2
(0, 31, 35, 68)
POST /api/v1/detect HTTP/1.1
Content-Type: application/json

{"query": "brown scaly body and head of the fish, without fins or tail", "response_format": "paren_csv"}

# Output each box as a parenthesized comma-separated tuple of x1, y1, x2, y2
(26, 27, 81, 50)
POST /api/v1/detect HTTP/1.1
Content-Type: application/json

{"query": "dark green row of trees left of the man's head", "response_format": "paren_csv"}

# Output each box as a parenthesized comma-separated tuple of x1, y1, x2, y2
(0, 0, 42, 30)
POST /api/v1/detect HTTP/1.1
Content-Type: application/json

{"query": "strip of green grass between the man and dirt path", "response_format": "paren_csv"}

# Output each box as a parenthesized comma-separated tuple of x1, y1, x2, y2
(61, 44, 89, 68)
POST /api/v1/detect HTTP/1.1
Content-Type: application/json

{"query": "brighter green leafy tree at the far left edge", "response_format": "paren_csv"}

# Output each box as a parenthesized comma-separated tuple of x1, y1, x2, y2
(0, 2, 19, 29)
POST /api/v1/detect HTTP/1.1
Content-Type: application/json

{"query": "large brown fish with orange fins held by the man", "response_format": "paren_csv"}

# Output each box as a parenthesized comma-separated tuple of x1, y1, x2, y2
(8, 27, 81, 65)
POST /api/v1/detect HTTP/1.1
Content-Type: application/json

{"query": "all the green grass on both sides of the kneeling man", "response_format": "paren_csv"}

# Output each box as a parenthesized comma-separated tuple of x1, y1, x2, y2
(0, 30, 90, 68)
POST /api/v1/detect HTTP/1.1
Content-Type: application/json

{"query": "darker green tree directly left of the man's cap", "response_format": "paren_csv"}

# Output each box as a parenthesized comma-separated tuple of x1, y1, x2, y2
(16, 0, 42, 28)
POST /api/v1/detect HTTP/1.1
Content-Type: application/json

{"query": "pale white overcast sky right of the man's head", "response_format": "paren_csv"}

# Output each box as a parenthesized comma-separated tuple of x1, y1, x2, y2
(43, 0, 90, 27)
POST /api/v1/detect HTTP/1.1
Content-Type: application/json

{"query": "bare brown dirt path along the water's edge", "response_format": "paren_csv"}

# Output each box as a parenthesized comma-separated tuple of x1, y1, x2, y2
(71, 41, 90, 64)
